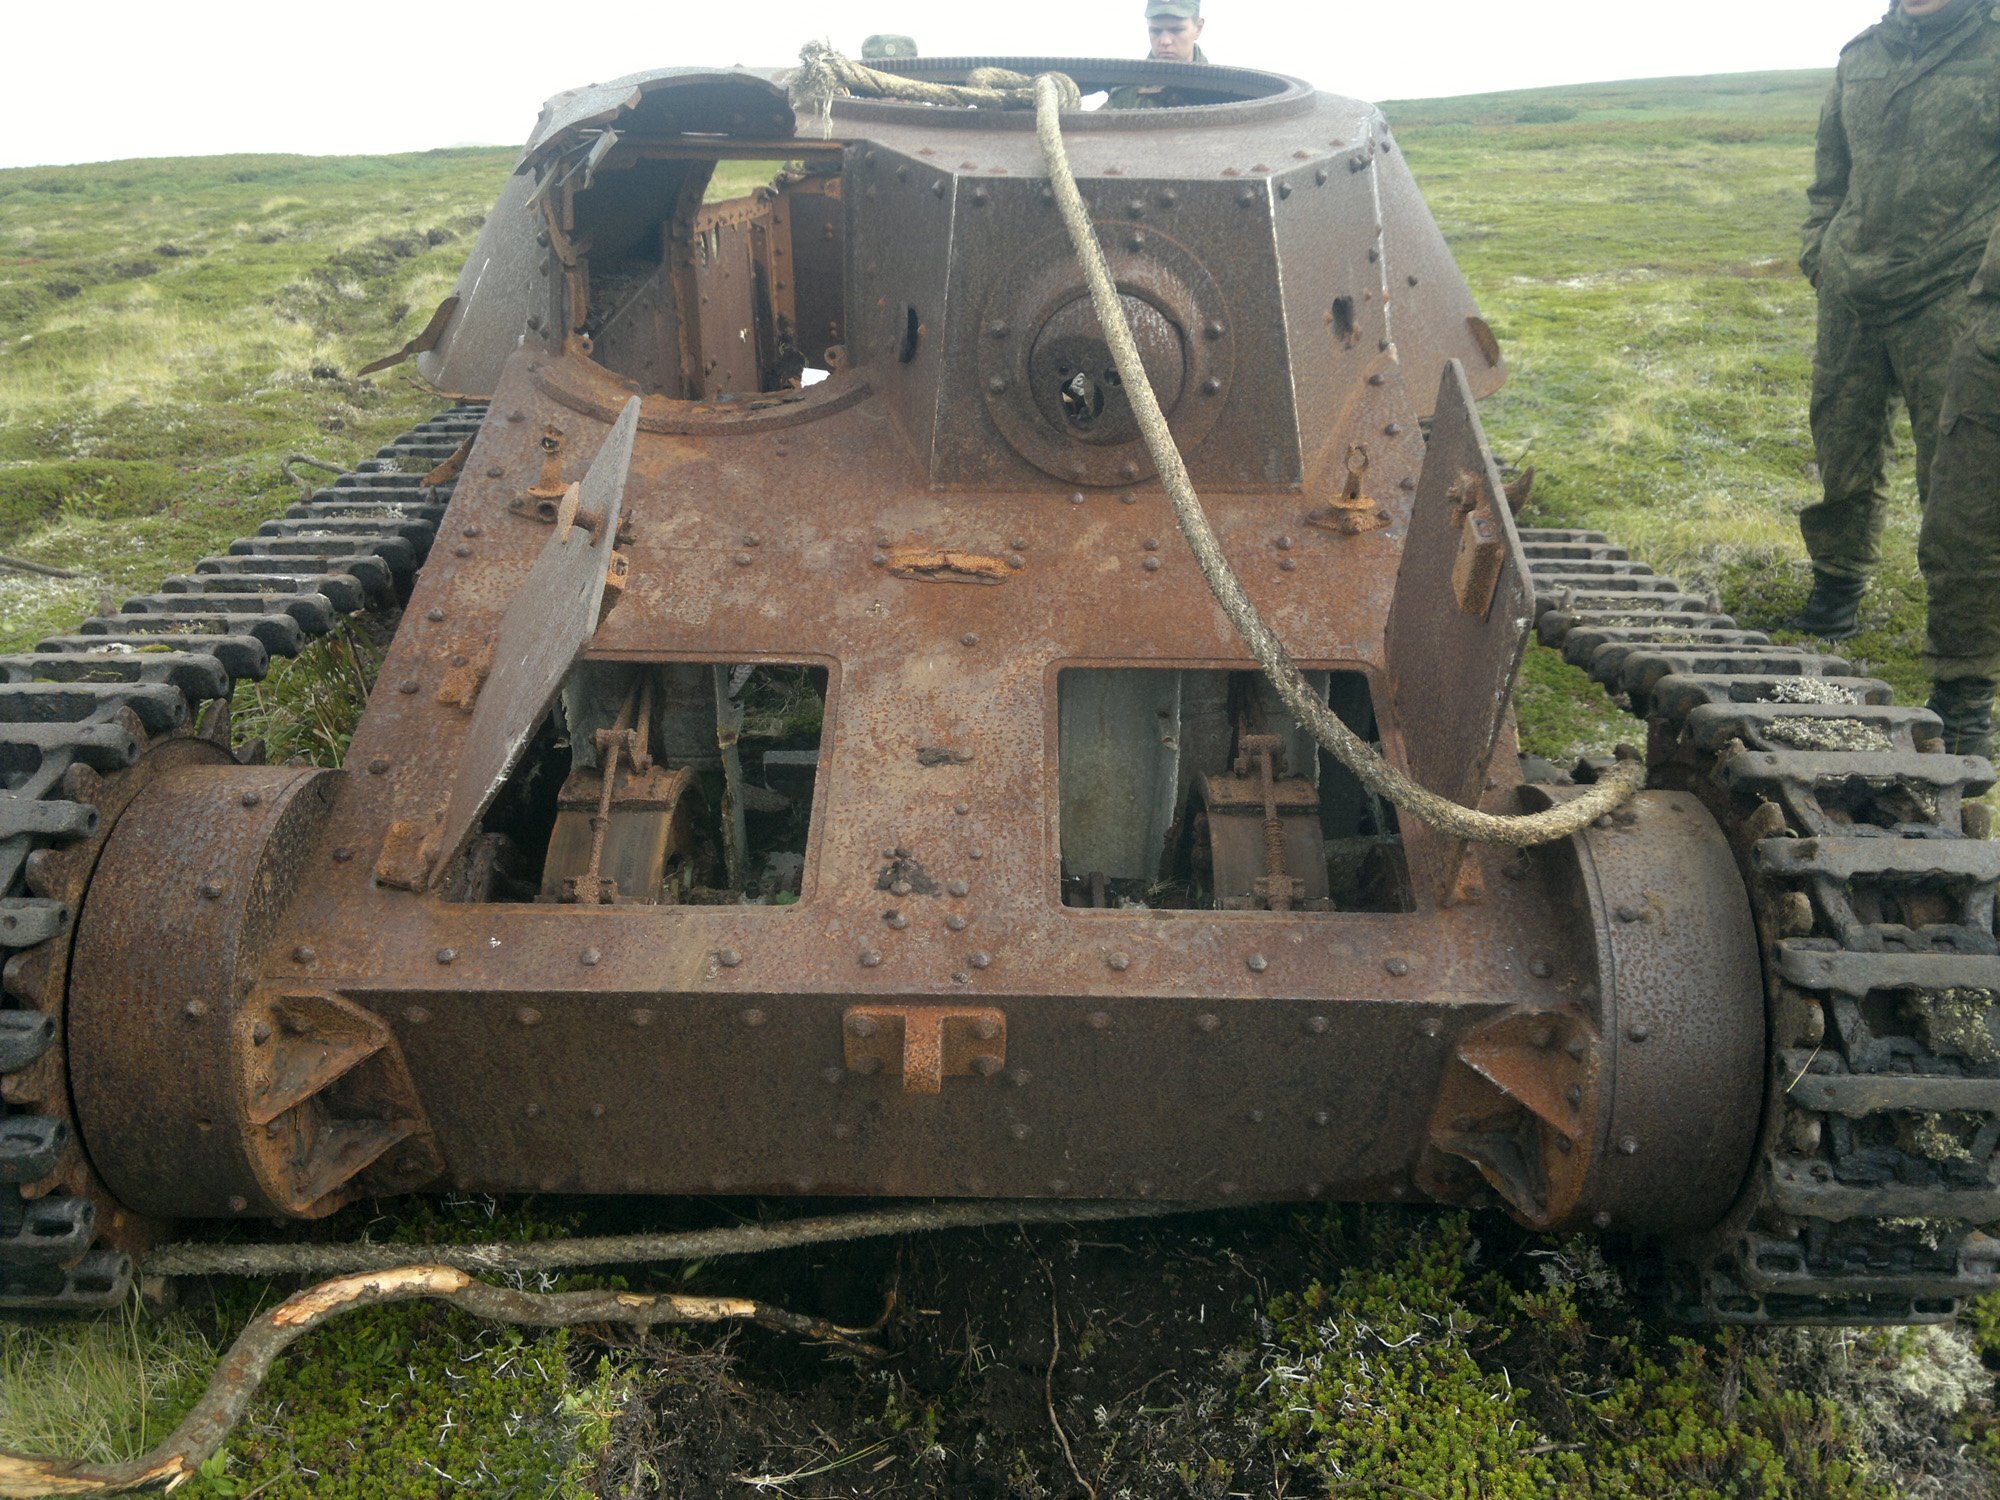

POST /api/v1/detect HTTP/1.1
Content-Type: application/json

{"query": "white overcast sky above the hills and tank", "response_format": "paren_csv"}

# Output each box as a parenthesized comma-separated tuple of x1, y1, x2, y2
(0, 0, 1888, 166)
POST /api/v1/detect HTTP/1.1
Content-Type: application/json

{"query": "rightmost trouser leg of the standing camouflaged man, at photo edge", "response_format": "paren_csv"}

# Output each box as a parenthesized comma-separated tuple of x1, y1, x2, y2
(1916, 326, 2000, 682)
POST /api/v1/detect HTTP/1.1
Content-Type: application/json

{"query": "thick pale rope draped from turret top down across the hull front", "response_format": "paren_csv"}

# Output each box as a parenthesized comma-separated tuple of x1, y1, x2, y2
(1032, 76, 1646, 848)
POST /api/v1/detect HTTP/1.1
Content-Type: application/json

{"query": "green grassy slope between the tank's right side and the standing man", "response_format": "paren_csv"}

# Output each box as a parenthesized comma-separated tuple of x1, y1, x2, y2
(1388, 72, 1928, 760)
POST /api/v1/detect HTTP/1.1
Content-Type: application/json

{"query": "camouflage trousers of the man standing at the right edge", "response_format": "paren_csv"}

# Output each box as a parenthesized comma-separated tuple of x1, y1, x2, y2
(1798, 290, 2000, 680)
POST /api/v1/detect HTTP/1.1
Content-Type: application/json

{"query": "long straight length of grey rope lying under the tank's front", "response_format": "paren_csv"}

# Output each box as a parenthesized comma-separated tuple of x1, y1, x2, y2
(140, 1200, 1210, 1276)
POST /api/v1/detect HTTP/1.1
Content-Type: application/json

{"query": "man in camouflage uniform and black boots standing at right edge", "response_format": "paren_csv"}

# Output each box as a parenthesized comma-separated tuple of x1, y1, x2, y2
(1794, 0, 2000, 752)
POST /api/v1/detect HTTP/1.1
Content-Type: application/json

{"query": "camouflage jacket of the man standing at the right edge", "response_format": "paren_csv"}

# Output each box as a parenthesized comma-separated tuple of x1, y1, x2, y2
(1800, 0, 2000, 318)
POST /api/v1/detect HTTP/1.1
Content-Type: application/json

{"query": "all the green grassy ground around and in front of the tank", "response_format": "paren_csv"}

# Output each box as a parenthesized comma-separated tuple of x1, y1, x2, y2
(0, 74, 2000, 1500)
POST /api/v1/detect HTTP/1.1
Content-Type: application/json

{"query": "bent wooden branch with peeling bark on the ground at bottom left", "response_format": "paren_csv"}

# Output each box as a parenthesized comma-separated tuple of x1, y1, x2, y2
(0, 1266, 882, 1500)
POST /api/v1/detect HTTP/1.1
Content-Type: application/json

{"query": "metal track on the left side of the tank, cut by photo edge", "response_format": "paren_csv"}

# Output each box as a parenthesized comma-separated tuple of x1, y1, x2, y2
(0, 404, 486, 1312)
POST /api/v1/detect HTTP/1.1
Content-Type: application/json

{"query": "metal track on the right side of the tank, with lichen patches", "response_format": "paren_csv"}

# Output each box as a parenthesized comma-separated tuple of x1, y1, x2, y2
(1522, 528, 2000, 1324)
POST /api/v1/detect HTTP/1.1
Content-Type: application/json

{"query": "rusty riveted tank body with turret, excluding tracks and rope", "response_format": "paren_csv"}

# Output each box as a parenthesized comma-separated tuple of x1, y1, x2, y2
(50, 62, 1764, 1272)
